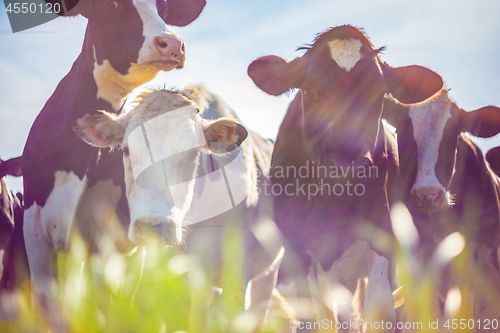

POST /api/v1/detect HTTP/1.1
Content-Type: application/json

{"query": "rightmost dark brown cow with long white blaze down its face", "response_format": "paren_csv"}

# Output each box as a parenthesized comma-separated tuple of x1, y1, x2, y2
(383, 80, 500, 318)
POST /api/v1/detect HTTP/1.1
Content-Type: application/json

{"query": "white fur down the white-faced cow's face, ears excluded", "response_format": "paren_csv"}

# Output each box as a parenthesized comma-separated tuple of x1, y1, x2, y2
(124, 105, 201, 241)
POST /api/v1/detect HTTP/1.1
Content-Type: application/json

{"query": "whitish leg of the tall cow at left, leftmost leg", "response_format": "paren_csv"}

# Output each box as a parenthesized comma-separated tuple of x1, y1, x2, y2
(24, 204, 67, 332)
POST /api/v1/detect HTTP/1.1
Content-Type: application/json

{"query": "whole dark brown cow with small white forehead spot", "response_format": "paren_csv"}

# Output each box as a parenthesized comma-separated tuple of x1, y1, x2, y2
(248, 25, 440, 328)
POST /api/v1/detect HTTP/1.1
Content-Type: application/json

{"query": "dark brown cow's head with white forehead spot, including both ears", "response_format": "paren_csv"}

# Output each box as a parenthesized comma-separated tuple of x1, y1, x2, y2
(248, 25, 440, 163)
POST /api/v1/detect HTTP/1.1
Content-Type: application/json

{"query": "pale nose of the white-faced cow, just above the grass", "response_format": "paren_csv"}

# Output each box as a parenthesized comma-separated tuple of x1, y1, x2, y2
(135, 218, 182, 245)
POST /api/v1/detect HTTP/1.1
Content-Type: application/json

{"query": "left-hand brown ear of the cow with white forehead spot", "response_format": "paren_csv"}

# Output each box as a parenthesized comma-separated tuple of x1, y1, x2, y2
(248, 55, 307, 96)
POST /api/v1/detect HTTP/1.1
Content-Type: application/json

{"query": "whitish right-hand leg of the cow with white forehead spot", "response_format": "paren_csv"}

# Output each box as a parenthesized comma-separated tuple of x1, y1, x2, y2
(364, 250, 396, 333)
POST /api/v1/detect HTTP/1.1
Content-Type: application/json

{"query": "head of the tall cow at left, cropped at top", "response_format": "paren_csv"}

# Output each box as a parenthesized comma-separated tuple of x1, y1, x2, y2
(46, 0, 205, 108)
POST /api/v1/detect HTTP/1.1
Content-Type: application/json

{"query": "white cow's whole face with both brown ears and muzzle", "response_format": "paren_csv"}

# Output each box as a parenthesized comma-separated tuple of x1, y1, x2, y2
(76, 90, 247, 242)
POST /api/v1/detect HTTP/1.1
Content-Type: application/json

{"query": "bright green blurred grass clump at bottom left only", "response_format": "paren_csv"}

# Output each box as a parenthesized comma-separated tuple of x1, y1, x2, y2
(0, 229, 288, 333)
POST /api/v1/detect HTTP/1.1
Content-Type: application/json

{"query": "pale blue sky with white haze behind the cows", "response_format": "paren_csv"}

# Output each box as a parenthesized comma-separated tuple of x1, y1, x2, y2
(0, 0, 500, 191)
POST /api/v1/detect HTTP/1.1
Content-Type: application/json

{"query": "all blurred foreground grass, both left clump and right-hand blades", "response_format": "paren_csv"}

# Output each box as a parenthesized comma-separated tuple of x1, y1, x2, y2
(0, 205, 500, 333)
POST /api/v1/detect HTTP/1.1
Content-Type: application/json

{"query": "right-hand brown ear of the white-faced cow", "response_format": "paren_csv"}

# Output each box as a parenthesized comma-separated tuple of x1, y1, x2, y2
(203, 119, 248, 154)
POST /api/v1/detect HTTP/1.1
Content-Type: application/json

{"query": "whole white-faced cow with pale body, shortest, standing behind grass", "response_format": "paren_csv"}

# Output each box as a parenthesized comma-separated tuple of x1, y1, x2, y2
(75, 85, 283, 322)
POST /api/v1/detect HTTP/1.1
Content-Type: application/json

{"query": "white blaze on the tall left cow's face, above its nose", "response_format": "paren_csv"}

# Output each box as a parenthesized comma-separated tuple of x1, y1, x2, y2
(133, 0, 179, 64)
